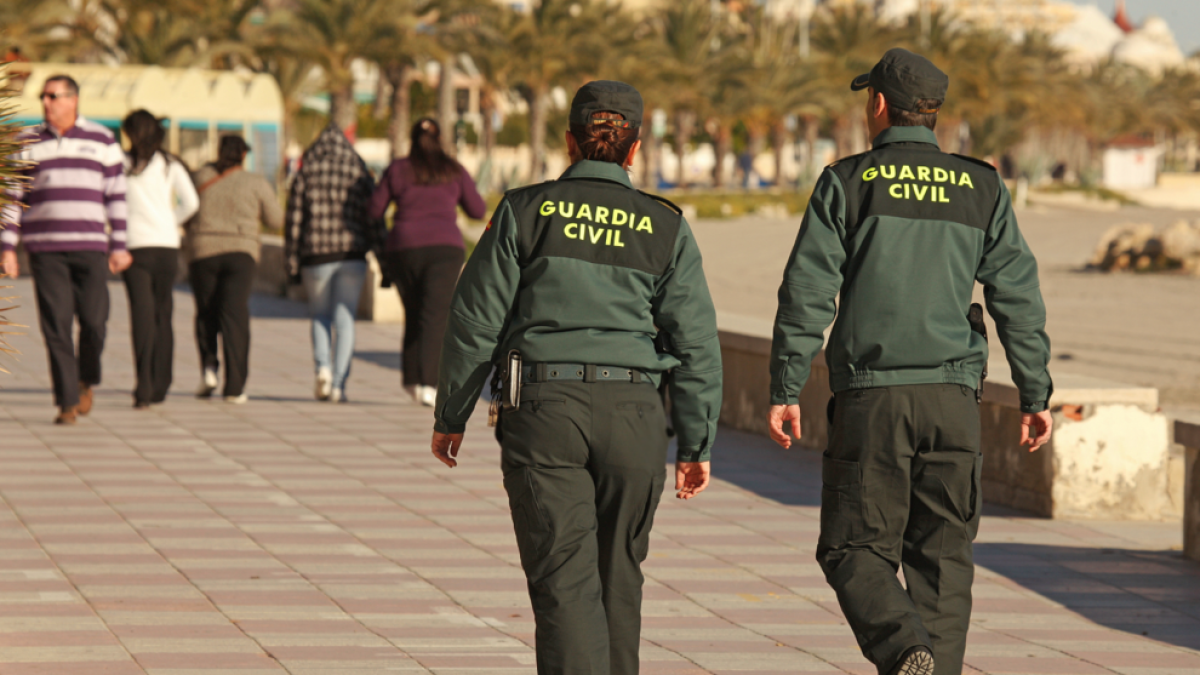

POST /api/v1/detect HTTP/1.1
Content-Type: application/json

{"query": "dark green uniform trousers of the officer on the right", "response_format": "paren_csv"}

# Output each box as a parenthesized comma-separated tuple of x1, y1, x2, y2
(817, 384, 982, 675)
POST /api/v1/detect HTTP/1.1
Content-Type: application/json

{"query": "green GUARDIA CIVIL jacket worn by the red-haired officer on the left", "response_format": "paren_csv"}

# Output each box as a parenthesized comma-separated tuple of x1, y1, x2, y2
(434, 161, 721, 461)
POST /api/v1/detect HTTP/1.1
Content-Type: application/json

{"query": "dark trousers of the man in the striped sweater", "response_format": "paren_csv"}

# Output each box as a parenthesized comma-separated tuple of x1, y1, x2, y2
(29, 251, 108, 410)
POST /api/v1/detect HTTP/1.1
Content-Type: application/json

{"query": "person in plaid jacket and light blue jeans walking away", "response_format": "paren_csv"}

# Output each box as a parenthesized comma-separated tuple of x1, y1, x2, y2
(283, 123, 388, 402)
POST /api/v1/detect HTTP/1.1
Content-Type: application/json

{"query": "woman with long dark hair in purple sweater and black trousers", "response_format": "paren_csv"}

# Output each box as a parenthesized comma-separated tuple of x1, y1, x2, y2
(371, 118, 486, 406)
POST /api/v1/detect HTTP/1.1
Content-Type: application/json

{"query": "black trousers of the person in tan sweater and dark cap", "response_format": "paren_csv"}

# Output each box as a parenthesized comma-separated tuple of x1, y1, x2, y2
(187, 253, 257, 396)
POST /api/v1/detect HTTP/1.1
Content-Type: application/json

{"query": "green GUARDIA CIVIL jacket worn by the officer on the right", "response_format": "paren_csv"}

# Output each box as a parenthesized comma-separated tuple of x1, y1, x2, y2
(770, 126, 1052, 412)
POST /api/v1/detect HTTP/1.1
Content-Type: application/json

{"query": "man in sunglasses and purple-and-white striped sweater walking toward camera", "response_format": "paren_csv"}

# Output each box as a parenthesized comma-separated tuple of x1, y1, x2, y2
(0, 76, 132, 424)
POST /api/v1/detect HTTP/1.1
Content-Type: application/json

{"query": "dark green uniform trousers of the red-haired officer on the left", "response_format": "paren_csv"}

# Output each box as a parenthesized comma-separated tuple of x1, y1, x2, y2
(498, 381, 667, 675)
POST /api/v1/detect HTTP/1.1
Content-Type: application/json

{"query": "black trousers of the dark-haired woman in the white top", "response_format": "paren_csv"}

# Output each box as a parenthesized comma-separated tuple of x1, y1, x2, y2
(125, 247, 179, 404)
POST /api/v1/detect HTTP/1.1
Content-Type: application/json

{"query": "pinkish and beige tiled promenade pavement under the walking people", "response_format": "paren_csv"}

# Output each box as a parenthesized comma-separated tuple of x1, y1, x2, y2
(0, 276, 1200, 675)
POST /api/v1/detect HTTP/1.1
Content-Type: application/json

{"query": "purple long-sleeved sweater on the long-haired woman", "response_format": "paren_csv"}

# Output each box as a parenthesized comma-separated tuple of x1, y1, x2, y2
(371, 157, 487, 251)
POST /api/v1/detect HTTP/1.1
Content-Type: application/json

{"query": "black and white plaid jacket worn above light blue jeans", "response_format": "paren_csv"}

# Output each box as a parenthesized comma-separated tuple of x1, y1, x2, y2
(283, 123, 388, 280)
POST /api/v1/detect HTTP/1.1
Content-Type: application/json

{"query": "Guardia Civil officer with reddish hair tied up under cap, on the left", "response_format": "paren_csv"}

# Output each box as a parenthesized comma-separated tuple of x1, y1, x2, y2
(433, 82, 721, 675)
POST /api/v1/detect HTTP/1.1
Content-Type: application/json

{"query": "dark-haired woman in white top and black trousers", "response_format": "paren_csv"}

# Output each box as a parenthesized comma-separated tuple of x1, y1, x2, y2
(121, 110, 200, 410)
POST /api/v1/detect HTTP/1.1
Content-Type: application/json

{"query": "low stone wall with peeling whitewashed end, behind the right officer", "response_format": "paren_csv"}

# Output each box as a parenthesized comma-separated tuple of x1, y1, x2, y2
(720, 315, 1181, 520)
